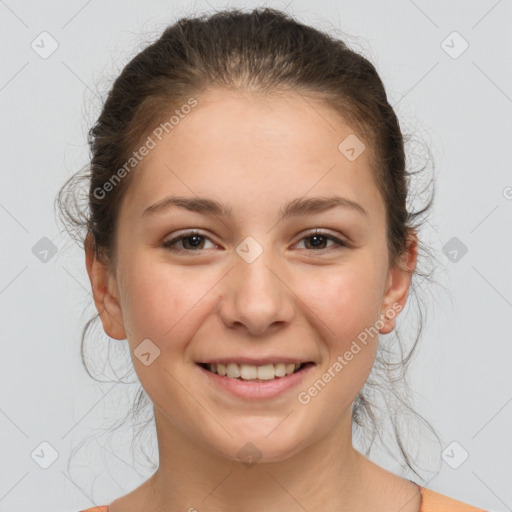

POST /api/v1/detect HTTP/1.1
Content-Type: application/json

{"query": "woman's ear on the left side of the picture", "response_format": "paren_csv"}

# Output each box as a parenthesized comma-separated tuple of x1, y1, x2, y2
(85, 233, 126, 340)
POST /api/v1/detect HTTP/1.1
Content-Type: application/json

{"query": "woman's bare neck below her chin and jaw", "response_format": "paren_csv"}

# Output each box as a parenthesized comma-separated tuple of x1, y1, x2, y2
(144, 407, 366, 512)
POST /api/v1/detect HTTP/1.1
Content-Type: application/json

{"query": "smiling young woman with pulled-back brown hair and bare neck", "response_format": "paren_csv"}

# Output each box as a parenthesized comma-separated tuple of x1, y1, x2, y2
(58, 9, 490, 512)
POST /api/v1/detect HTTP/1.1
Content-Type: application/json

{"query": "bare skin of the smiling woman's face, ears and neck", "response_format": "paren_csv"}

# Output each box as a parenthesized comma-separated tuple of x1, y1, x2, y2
(86, 89, 420, 512)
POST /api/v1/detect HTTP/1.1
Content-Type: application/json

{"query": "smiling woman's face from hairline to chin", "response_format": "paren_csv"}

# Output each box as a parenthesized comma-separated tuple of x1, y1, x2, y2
(88, 90, 414, 462)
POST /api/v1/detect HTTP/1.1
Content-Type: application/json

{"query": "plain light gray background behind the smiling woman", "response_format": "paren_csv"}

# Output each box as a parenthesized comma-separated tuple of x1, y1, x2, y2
(0, 0, 512, 512)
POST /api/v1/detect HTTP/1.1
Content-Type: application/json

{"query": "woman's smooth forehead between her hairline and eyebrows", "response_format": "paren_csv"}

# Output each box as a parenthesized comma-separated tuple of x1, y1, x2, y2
(120, 89, 383, 222)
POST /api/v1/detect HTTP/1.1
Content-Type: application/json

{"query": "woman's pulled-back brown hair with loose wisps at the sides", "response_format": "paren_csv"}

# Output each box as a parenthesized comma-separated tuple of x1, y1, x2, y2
(56, 8, 437, 480)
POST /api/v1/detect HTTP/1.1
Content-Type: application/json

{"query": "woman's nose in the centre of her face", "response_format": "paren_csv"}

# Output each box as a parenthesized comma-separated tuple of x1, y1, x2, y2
(218, 251, 295, 336)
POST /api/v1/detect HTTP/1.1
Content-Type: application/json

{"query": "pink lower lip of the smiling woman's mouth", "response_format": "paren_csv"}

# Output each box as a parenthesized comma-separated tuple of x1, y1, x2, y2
(197, 364, 315, 400)
